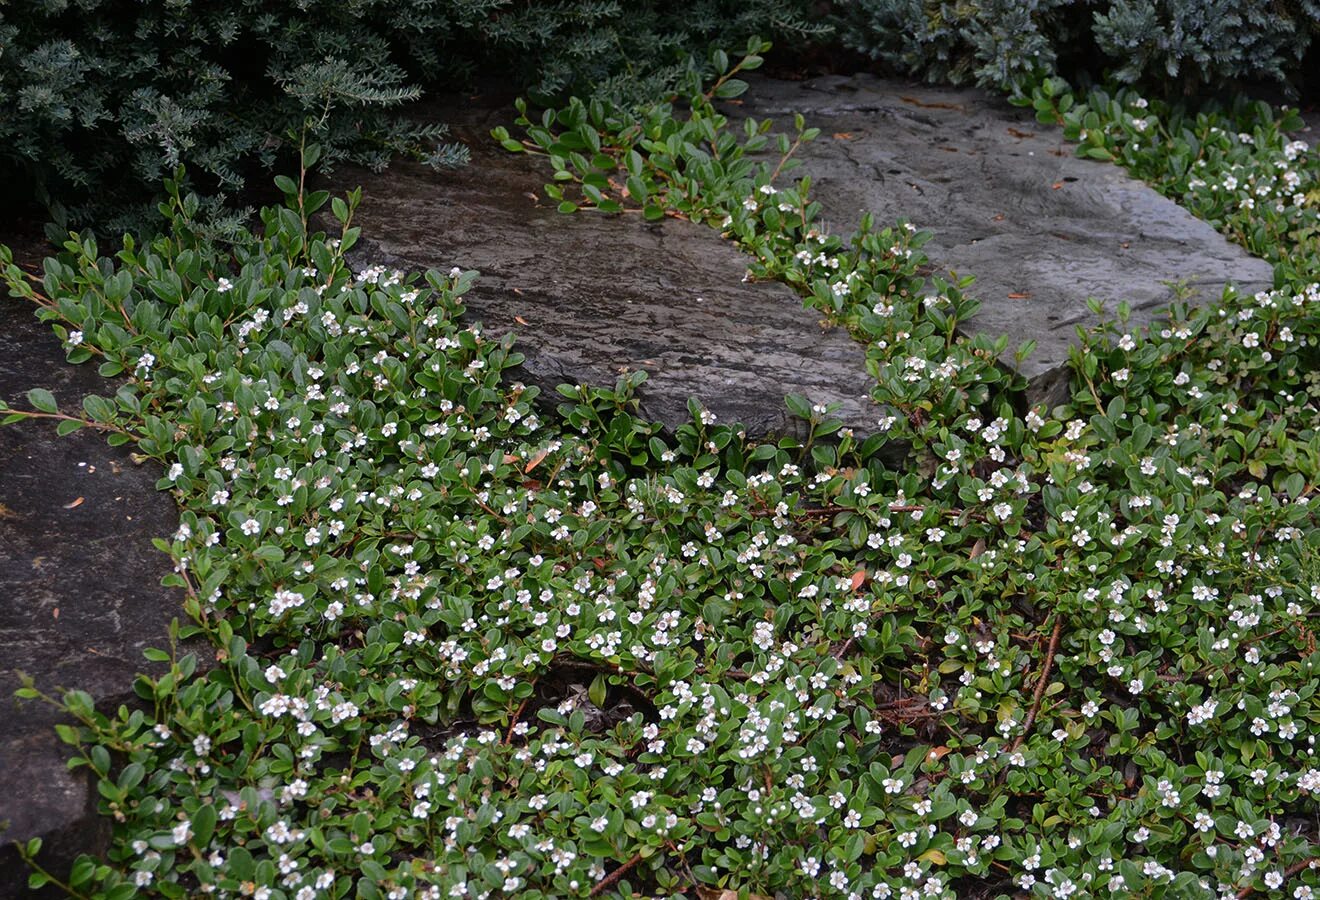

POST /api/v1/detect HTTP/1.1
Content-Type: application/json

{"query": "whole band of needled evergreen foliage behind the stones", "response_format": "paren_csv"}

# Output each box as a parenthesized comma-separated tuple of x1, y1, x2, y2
(0, 0, 1320, 234)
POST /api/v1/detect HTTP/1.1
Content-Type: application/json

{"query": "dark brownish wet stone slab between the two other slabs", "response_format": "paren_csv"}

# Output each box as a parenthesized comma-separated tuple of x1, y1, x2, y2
(334, 103, 878, 437)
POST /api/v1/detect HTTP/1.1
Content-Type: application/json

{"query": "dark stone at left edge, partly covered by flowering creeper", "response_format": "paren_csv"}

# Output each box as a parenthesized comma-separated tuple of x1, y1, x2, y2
(0, 301, 182, 897)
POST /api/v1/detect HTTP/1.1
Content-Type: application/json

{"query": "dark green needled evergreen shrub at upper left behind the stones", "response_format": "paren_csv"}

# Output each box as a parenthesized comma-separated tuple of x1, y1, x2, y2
(0, 0, 821, 226)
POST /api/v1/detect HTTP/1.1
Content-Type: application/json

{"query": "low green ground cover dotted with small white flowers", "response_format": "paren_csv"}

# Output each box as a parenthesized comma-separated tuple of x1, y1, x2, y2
(5, 38, 1320, 900)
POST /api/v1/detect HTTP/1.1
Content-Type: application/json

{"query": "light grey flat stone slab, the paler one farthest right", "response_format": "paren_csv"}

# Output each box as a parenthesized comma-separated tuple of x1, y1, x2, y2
(730, 75, 1274, 404)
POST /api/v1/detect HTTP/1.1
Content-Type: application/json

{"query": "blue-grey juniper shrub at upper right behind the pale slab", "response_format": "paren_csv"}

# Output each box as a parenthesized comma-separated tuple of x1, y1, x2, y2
(840, 0, 1320, 94)
